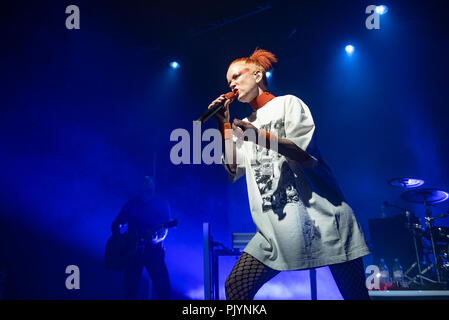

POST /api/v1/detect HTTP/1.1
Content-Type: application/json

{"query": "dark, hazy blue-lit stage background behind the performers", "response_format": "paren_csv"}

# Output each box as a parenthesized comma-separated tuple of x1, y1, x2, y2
(0, 0, 449, 299)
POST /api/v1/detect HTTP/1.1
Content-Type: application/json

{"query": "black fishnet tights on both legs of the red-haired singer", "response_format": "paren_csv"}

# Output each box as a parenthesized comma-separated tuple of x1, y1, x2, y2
(225, 252, 369, 300)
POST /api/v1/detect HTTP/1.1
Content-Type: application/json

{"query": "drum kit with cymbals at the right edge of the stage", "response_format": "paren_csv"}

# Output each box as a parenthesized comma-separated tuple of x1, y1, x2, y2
(388, 177, 449, 289)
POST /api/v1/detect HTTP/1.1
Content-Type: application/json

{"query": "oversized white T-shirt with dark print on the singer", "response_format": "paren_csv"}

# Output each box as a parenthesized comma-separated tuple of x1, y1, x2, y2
(225, 95, 369, 270)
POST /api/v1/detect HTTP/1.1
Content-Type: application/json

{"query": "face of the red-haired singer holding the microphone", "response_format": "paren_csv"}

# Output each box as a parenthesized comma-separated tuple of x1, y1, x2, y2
(226, 62, 259, 102)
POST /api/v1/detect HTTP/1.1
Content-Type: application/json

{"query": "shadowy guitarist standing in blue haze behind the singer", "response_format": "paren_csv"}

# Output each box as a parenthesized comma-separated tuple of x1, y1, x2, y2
(111, 176, 170, 300)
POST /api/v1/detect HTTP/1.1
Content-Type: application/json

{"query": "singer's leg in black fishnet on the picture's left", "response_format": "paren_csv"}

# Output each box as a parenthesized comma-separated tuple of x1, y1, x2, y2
(225, 252, 279, 300)
